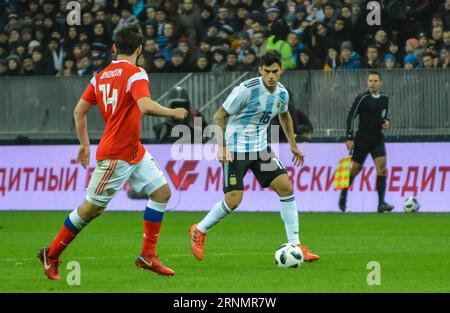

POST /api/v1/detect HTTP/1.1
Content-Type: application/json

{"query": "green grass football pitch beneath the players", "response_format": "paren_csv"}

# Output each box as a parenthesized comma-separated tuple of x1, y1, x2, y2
(0, 212, 450, 292)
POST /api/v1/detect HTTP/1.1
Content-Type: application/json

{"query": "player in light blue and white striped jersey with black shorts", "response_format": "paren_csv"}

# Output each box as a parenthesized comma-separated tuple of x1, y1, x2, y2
(190, 51, 319, 261)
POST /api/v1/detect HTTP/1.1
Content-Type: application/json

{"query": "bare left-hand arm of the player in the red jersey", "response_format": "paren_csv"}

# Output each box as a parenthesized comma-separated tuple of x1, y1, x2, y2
(73, 99, 94, 168)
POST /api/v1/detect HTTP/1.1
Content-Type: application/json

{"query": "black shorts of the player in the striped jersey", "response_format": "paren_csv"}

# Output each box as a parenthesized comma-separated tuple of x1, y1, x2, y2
(223, 147, 287, 193)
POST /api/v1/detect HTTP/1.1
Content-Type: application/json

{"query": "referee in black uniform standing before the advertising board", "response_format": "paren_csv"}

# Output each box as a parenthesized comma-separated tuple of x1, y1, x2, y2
(339, 71, 394, 213)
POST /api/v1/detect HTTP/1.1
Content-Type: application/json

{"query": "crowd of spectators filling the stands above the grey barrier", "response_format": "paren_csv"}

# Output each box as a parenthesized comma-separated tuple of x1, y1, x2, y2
(0, 0, 450, 76)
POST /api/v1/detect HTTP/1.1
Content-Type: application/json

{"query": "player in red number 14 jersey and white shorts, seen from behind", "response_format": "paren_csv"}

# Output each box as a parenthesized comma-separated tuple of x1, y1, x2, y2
(38, 25, 188, 280)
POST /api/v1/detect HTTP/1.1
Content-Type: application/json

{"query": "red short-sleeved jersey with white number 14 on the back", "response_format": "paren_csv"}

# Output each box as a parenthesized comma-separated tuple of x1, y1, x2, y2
(81, 60, 150, 163)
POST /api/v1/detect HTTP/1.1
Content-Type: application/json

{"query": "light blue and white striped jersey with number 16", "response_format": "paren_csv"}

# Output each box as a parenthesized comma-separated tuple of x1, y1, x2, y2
(222, 77, 289, 152)
